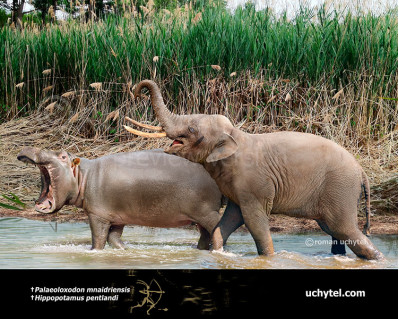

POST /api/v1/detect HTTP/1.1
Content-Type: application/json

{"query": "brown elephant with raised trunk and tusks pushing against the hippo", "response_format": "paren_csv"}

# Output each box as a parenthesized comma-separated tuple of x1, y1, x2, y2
(125, 80, 384, 260)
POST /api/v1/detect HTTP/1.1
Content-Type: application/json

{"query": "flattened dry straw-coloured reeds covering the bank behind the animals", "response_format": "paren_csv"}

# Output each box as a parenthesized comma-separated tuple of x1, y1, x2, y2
(0, 113, 398, 234)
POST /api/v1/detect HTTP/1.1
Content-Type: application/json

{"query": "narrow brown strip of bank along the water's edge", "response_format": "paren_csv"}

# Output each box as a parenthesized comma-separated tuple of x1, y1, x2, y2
(0, 208, 398, 235)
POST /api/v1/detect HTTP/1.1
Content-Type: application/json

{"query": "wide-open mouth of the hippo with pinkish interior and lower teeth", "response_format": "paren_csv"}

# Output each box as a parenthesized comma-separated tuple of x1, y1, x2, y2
(18, 156, 56, 214)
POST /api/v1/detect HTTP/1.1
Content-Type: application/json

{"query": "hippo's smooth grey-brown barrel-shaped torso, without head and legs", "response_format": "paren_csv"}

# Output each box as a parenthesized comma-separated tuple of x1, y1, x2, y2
(82, 150, 222, 227)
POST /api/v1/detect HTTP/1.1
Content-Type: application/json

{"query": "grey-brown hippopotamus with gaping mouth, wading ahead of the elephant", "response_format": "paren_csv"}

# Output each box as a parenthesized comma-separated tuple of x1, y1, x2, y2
(17, 147, 224, 249)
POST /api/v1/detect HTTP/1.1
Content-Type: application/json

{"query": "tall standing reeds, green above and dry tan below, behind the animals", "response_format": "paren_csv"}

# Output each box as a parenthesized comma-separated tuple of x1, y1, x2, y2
(0, 5, 398, 148)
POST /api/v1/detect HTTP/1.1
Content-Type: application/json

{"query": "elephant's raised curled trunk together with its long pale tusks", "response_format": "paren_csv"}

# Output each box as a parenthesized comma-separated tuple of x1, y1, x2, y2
(125, 80, 179, 137)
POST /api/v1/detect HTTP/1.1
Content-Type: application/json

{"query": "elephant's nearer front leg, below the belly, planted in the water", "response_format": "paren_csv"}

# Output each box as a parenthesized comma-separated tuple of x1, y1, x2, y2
(241, 201, 274, 256)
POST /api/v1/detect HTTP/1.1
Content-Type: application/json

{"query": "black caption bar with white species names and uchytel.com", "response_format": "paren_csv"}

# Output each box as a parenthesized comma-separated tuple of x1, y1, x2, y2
(0, 270, 398, 318)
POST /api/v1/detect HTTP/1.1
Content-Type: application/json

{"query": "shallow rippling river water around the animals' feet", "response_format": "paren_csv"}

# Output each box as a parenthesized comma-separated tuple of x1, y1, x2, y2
(0, 218, 398, 269)
